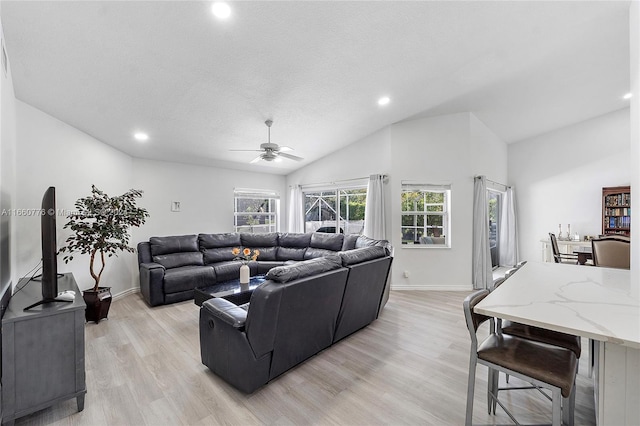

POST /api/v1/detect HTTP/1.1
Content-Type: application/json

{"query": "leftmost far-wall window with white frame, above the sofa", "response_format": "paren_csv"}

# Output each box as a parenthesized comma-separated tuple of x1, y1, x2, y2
(233, 189, 280, 234)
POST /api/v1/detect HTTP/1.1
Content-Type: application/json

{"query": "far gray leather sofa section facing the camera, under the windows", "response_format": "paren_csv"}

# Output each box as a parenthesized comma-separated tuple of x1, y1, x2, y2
(138, 232, 391, 306)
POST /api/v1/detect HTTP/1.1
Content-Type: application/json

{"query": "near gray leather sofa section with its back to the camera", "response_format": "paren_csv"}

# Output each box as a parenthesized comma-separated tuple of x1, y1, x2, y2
(200, 246, 392, 393)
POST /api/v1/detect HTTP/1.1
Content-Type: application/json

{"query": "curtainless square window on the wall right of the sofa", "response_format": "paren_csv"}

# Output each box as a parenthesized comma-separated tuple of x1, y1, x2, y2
(401, 183, 451, 247)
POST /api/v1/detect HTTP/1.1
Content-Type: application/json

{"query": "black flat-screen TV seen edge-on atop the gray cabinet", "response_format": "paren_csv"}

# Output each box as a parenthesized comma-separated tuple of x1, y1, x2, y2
(24, 186, 60, 311)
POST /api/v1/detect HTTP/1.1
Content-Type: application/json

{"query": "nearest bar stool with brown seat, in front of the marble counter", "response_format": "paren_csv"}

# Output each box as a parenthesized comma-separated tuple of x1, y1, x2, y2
(463, 290, 578, 426)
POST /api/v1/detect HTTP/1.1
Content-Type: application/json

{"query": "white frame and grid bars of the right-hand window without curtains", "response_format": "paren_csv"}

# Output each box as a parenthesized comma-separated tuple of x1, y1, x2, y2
(400, 182, 452, 249)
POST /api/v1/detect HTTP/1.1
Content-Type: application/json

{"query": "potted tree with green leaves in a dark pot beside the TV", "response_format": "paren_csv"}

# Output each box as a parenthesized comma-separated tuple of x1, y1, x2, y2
(60, 185, 149, 323)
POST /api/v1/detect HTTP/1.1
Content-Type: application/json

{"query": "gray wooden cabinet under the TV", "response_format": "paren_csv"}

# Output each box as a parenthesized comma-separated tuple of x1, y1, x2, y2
(1, 273, 87, 424)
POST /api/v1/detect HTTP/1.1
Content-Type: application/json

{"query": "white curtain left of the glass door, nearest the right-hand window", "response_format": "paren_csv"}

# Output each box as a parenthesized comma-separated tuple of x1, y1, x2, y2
(472, 176, 493, 289)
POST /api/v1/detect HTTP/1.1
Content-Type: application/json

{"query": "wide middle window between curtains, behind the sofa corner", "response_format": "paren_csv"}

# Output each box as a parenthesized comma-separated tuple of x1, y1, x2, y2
(303, 185, 367, 234)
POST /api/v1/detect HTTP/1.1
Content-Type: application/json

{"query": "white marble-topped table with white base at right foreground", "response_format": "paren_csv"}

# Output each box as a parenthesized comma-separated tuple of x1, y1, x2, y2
(474, 261, 640, 426)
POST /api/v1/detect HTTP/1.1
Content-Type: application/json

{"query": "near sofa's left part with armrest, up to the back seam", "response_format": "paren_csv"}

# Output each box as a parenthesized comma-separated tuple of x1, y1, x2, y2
(200, 256, 348, 393)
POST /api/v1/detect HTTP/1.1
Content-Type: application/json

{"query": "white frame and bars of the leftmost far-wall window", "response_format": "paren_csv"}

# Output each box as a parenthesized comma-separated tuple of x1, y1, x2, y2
(233, 188, 280, 234)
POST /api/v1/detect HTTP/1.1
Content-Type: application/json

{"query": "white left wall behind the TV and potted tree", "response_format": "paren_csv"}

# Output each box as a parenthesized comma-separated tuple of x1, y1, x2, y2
(13, 101, 137, 295)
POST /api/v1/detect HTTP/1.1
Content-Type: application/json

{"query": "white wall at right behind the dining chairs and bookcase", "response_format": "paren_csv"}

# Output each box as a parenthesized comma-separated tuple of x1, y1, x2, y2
(508, 108, 631, 260)
